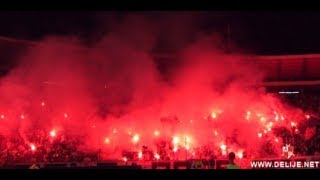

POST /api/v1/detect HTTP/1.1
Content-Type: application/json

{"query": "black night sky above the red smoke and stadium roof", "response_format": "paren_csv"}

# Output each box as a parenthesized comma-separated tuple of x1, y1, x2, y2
(0, 11, 320, 54)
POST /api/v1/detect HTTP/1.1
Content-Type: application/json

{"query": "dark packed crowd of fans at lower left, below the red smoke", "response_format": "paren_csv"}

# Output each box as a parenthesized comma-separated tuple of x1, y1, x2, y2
(0, 130, 98, 166)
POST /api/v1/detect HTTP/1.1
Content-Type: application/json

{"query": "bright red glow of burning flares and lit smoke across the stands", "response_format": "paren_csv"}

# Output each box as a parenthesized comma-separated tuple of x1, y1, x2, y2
(0, 37, 313, 164)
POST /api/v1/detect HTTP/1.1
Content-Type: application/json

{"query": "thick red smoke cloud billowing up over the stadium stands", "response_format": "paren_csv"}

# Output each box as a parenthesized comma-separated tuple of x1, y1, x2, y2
(0, 15, 302, 158)
